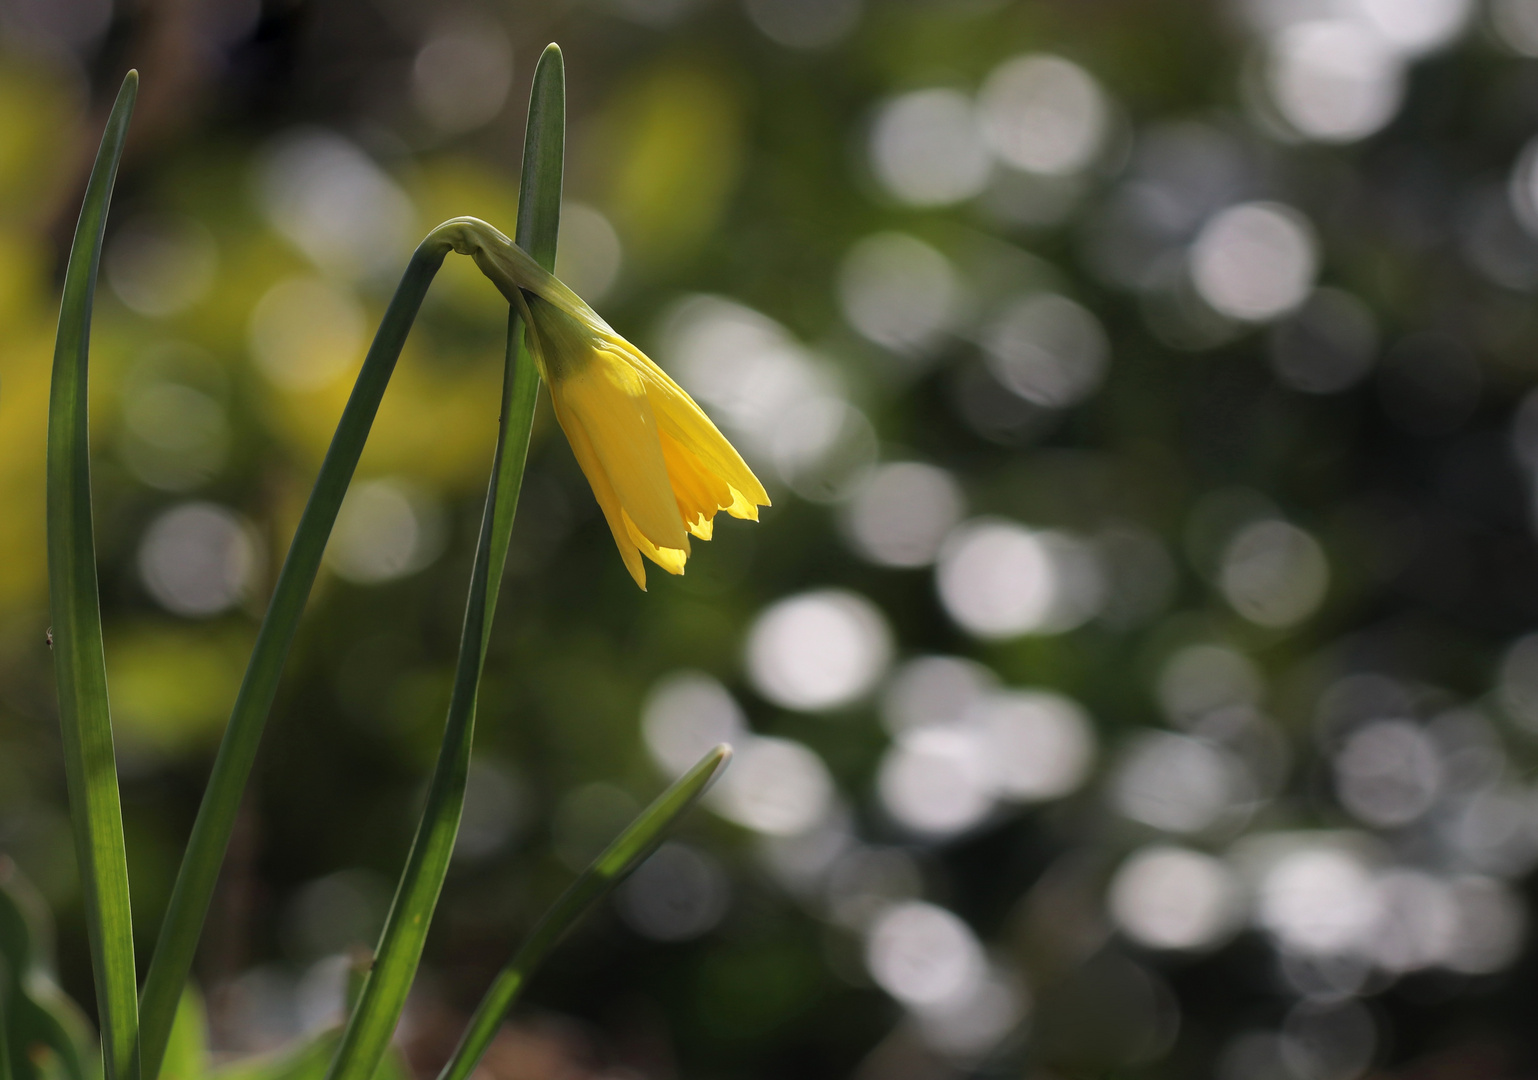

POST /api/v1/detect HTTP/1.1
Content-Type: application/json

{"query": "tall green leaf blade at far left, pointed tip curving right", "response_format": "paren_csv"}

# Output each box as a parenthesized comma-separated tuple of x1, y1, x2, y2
(48, 71, 138, 1080)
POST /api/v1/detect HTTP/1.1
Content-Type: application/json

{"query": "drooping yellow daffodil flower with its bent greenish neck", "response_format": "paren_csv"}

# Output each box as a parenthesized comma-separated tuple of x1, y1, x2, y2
(435, 217, 769, 589)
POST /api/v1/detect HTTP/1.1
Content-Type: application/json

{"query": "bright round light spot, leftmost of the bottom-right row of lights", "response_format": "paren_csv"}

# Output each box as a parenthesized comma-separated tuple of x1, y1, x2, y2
(1109, 845, 1243, 949)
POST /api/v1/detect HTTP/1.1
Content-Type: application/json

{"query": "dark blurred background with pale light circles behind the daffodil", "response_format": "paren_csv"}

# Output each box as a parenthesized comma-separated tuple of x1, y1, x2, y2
(9, 0, 1538, 1080)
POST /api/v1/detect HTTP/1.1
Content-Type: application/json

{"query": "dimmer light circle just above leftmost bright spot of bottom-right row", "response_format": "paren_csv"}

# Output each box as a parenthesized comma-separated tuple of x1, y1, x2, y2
(1110, 731, 1255, 832)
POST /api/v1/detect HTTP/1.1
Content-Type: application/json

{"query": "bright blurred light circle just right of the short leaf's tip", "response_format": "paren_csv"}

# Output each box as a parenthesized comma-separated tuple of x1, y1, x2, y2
(709, 735, 834, 837)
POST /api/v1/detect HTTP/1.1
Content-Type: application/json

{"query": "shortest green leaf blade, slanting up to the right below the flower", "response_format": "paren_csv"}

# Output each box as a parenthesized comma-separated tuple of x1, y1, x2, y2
(438, 745, 732, 1080)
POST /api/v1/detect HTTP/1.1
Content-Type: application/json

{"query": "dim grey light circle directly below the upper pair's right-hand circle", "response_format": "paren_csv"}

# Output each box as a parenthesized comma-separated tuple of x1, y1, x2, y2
(983, 292, 1110, 409)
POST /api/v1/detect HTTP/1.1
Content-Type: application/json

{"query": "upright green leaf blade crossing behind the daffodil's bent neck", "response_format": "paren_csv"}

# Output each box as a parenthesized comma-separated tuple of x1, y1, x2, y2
(328, 46, 566, 1080)
